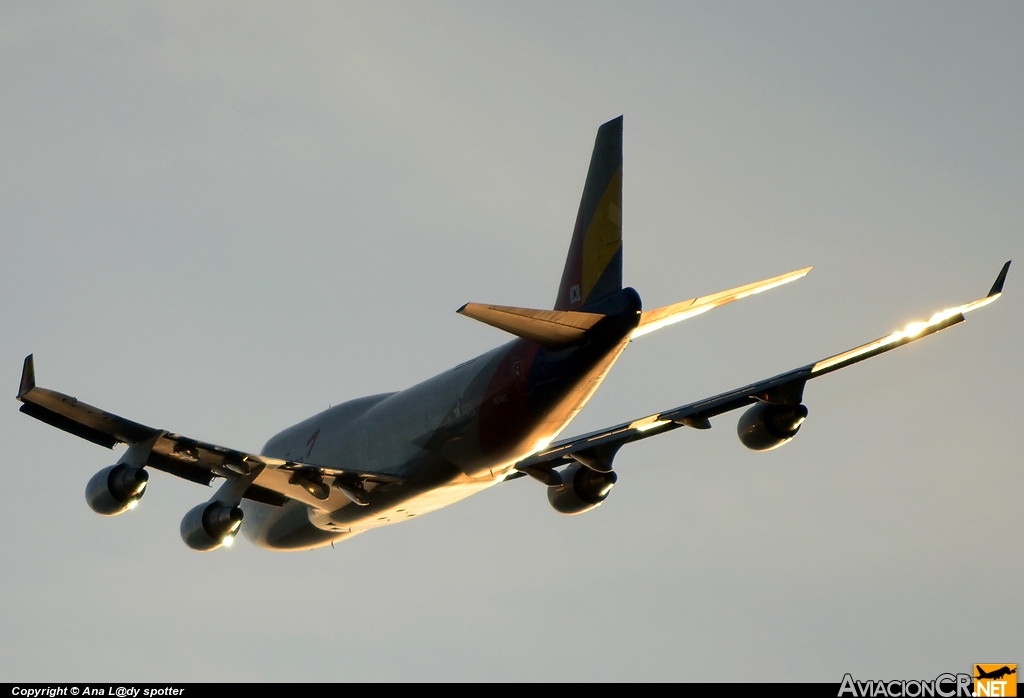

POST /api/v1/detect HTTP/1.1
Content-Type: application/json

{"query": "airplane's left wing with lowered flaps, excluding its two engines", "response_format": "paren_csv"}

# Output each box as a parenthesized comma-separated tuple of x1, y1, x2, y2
(17, 354, 400, 507)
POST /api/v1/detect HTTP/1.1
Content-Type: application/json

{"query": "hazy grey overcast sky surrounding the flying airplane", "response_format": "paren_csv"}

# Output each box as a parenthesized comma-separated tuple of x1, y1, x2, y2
(0, 2, 1024, 682)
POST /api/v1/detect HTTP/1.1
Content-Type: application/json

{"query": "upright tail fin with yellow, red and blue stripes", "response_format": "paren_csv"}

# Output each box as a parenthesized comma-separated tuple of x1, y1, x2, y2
(555, 117, 623, 310)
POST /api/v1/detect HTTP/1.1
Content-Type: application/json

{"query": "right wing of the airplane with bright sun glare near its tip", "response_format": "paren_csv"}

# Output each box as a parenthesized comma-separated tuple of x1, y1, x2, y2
(516, 262, 1010, 472)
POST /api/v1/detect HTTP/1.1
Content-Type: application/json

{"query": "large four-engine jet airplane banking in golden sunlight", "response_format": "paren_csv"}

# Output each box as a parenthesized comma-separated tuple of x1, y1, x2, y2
(17, 117, 1010, 551)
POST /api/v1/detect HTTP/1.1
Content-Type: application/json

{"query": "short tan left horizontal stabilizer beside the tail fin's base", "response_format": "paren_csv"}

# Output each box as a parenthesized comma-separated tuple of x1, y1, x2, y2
(458, 303, 604, 347)
